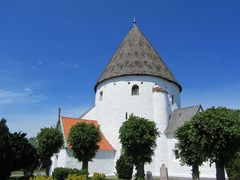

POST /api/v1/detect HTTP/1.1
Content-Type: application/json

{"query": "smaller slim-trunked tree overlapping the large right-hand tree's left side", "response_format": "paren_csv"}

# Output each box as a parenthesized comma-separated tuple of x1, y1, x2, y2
(176, 121, 206, 179)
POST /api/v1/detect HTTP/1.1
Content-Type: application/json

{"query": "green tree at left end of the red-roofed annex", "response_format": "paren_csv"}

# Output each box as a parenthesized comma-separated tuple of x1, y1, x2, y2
(37, 127, 63, 175)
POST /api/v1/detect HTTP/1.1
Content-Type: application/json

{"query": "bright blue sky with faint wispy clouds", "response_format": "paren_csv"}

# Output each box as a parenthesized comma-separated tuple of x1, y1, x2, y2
(0, 0, 240, 137)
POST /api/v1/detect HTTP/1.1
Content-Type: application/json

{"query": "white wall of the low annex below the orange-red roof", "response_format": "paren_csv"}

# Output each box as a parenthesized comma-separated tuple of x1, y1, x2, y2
(51, 148, 115, 176)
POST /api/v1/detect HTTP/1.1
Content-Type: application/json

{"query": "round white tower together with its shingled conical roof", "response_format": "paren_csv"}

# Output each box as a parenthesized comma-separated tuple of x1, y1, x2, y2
(95, 23, 182, 174)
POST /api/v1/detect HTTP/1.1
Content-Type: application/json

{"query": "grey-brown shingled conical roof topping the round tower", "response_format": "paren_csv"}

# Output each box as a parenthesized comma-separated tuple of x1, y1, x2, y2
(95, 23, 182, 91)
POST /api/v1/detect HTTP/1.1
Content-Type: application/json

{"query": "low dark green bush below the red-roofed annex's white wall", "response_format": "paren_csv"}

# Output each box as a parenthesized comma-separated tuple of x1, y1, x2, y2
(52, 168, 88, 180)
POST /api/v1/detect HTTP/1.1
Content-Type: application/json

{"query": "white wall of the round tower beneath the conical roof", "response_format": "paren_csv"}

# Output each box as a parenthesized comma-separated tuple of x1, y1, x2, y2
(95, 75, 181, 173)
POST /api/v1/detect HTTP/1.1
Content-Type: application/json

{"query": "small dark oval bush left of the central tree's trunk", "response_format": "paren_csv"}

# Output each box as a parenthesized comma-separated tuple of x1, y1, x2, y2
(116, 155, 133, 179)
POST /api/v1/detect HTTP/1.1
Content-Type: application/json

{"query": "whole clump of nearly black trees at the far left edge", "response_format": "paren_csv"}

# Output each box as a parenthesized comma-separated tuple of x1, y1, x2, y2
(0, 119, 38, 179)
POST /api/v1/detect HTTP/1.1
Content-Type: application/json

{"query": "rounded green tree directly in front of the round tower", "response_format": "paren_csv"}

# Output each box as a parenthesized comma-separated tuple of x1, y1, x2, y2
(119, 115, 160, 178)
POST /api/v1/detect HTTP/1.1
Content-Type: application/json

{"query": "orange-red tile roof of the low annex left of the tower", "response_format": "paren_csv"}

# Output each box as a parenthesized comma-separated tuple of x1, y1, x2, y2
(62, 117, 115, 151)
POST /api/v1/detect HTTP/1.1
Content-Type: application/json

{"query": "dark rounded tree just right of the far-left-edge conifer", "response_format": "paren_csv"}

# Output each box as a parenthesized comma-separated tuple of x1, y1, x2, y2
(9, 132, 38, 175)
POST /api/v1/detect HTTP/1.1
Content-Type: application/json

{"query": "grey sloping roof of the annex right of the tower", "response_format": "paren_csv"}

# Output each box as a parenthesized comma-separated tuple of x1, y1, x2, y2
(165, 105, 202, 133)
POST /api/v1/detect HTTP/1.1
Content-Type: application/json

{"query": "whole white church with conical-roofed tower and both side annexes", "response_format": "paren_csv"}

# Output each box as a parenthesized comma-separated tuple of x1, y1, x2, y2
(51, 23, 215, 178)
